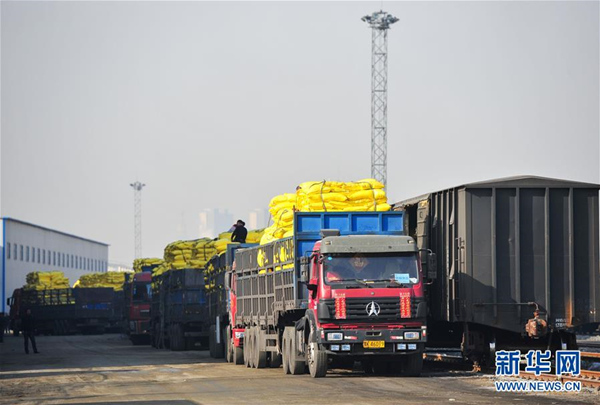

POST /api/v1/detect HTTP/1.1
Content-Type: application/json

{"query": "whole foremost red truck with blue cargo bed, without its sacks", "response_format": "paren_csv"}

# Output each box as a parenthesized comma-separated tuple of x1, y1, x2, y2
(225, 212, 435, 377)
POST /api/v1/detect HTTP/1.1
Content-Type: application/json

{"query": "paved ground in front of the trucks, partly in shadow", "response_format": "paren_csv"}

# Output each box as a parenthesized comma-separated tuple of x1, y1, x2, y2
(0, 335, 600, 405)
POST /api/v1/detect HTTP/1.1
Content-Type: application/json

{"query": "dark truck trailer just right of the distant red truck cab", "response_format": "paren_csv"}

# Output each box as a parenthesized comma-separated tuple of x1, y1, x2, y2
(150, 268, 210, 351)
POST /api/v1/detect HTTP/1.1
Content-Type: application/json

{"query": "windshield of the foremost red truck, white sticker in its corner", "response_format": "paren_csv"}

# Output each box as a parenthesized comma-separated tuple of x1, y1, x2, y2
(323, 252, 419, 284)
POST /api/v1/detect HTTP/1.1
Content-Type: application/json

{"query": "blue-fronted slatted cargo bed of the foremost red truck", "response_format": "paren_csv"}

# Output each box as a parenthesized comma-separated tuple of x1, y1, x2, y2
(235, 211, 404, 325)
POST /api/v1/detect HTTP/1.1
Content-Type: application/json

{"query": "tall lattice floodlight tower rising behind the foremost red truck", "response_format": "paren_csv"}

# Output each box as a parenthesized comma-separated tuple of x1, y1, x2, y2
(362, 10, 398, 185)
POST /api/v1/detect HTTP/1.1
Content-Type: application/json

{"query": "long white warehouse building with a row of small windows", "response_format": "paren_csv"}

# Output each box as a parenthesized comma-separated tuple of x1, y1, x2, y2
(0, 218, 108, 312)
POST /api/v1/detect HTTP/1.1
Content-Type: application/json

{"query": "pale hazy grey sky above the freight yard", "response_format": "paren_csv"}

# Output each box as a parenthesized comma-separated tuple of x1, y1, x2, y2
(0, 1, 600, 262)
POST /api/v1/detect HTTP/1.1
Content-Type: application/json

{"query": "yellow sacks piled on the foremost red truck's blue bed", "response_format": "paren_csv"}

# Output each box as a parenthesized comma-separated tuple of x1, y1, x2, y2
(260, 179, 391, 245)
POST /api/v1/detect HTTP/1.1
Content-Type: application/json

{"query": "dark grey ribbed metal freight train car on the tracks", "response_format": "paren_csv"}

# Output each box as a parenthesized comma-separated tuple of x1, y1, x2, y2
(394, 176, 600, 361)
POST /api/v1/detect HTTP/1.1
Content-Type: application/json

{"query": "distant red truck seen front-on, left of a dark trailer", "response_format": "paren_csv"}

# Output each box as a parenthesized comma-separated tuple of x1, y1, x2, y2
(125, 270, 152, 345)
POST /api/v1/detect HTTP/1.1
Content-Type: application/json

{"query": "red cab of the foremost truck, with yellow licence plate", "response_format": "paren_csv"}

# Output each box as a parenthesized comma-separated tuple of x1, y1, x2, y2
(302, 235, 427, 375)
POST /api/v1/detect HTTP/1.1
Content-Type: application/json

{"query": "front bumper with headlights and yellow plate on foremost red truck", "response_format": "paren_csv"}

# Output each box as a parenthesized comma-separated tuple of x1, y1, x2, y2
(318, 328, 427, 356)
